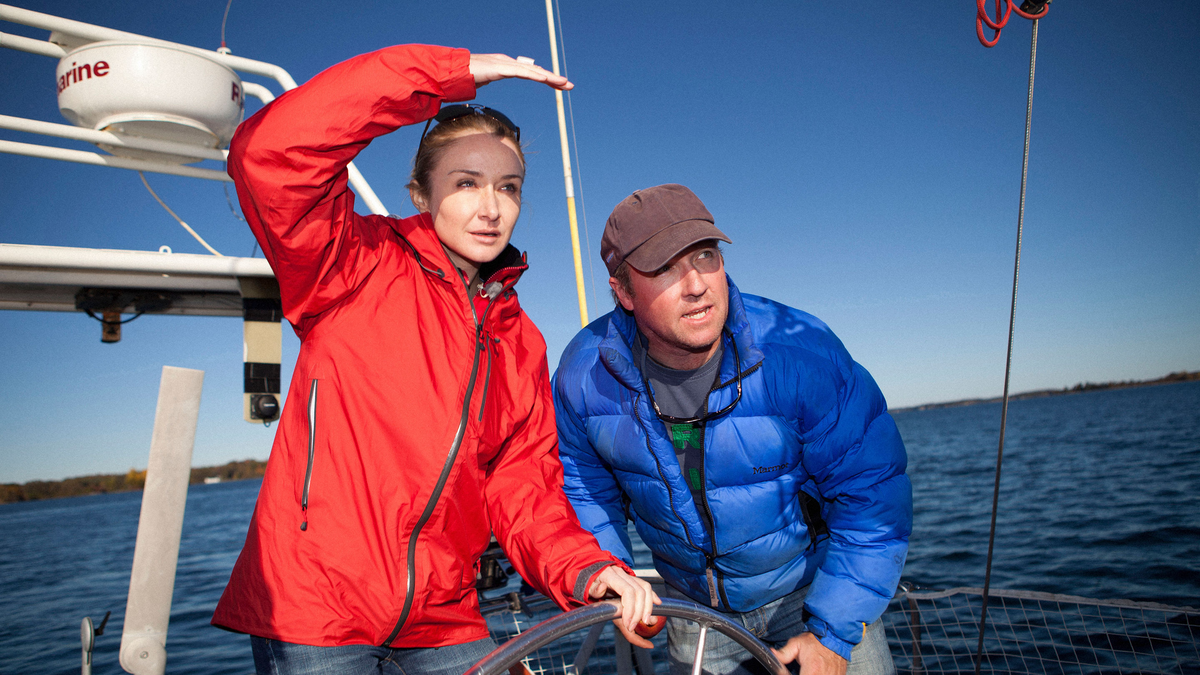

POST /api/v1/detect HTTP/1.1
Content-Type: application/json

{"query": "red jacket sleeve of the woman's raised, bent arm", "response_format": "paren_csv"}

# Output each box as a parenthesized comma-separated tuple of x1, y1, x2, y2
(229, 44, 475, 335)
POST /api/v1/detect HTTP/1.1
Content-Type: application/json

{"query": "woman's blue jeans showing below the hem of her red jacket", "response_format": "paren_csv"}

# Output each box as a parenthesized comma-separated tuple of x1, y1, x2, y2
(250, 635, 496, 675)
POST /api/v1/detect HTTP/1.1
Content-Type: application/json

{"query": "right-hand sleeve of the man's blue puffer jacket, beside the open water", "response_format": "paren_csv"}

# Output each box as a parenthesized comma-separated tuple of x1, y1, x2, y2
(803, 352, 912, 659)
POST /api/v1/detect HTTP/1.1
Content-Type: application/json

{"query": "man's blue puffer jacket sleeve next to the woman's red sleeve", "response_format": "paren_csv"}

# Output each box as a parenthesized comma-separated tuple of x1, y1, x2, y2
(554, 342, 634, 566)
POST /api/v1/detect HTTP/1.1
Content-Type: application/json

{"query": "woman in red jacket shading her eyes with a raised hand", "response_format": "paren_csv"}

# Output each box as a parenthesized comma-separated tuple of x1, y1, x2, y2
(212, 46, 658, 674)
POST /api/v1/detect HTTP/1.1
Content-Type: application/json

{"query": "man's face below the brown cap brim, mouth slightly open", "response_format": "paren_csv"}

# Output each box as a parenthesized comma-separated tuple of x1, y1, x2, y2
(608, 240, 730, 370)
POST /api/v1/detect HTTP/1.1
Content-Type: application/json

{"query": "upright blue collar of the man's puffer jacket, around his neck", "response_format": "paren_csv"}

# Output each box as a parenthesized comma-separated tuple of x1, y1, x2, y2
(600, 275, 763, 393)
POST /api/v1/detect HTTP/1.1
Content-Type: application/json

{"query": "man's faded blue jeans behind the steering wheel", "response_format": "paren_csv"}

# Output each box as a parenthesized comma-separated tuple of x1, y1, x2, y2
(665, 586, 895, 675)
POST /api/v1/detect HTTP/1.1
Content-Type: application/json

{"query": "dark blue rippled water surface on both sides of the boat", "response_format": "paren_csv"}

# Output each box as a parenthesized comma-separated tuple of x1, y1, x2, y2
(0, 382, 1200, 675)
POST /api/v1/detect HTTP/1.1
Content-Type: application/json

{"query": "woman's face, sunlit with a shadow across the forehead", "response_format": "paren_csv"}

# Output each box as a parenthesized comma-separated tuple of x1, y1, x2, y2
(413, 133, 524, 277)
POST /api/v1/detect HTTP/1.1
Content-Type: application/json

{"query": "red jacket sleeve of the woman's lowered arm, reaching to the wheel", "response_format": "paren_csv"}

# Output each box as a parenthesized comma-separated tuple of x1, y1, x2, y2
(485, 359, 632, 609)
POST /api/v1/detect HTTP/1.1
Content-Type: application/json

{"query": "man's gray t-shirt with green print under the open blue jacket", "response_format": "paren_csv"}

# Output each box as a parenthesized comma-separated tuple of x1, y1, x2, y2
(634, 334, 725, 520)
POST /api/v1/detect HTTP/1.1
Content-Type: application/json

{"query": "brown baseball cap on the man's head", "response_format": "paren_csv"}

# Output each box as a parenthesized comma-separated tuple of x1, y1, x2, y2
(600, 183, 733, 276)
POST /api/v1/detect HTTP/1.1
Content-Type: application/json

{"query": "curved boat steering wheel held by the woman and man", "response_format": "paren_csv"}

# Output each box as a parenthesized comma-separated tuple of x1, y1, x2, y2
(463, 598, 787, 675)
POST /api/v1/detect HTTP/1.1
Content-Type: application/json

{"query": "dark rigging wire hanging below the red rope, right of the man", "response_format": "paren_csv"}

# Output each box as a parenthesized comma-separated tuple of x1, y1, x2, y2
(974, 11, 1049, 675)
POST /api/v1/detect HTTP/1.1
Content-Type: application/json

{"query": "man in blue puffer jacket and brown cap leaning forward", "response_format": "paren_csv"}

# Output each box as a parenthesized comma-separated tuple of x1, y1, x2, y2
(554, 185, 912, 675)
